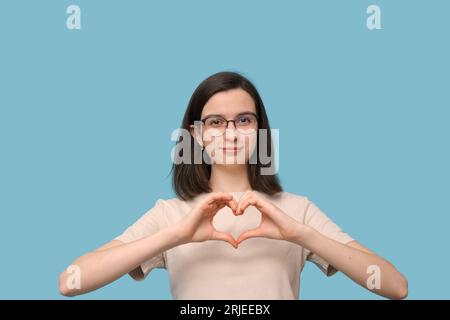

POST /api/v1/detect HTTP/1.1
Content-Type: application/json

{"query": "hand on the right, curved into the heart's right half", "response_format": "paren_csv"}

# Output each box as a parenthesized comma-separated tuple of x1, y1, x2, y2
(235, 190, 301, 244)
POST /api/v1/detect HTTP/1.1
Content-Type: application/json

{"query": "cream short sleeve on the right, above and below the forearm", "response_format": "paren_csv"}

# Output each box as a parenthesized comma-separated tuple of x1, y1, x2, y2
(304, 198, 354, 277)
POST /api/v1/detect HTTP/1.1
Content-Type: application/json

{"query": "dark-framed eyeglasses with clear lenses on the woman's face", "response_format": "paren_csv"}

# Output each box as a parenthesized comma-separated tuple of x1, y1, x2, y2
(201, 112, 258, 136)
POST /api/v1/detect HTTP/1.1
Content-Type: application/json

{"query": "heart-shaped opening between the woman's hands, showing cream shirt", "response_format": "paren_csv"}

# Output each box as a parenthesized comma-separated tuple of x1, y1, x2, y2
(213, 195, 262, 240)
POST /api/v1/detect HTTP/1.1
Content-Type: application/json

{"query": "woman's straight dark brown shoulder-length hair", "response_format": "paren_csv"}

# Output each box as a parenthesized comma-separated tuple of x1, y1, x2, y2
(171, 71, 283, 200)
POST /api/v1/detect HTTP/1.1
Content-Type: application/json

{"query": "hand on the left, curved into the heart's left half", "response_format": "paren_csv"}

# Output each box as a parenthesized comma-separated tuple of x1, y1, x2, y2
(177, 192, 238, 249)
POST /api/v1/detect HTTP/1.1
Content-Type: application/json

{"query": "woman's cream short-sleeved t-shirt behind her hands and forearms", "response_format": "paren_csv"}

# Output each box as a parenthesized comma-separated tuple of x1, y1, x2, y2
(115, 191, 353, 299)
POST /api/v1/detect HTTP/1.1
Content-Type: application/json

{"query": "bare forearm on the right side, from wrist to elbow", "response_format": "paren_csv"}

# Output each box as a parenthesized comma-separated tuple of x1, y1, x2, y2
(293, 224, 408, 299)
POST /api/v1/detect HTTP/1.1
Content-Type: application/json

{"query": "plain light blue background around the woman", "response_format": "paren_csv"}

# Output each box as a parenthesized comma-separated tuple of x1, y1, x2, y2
(0, 0, 450, 299)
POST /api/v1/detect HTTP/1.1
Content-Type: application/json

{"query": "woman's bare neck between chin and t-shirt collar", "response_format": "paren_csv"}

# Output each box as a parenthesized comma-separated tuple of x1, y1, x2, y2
(209, 164, 251, 192)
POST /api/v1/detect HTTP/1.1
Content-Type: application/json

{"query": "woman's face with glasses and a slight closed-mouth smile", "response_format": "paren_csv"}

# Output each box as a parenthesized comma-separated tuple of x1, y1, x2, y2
(192, 89, 258, 165)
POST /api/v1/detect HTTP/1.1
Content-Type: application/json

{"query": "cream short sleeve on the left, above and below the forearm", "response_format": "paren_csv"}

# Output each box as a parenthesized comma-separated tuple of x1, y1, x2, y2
(114, 199, 166, 280)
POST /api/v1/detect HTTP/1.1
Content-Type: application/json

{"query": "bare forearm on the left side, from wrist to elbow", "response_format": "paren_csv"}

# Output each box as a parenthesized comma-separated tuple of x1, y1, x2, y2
(60, 227, 184, 296)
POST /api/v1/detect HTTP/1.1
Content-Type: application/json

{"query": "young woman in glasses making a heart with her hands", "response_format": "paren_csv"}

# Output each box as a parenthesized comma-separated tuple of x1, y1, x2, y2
(60, 72, 408, 299)
